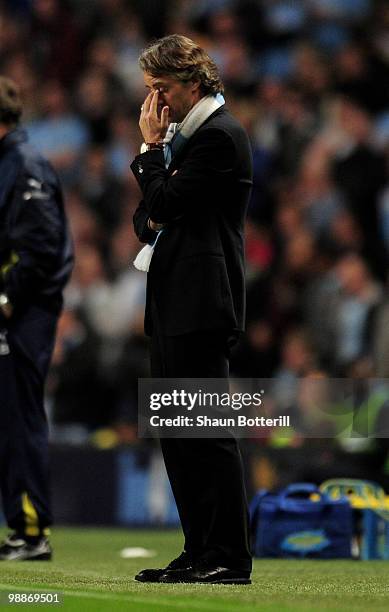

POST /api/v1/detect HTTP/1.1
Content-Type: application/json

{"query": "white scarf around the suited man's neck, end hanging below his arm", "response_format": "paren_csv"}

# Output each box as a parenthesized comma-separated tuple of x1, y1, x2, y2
(134, 93, 225, 272)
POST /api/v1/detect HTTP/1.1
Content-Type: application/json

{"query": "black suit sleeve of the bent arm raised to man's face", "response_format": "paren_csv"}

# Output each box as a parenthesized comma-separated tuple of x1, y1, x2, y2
(131, 128, 236, 223)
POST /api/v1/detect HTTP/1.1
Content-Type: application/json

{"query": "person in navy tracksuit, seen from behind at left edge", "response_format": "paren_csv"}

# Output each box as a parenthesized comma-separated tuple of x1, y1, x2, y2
(0, 76, 73, 560)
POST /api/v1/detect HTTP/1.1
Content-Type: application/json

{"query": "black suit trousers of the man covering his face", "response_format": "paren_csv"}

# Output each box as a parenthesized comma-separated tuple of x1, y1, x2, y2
(151, 326, 251, 570)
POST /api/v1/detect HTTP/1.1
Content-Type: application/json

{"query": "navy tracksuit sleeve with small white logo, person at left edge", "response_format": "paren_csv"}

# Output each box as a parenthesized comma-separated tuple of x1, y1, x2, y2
(0, 170, 65, 306)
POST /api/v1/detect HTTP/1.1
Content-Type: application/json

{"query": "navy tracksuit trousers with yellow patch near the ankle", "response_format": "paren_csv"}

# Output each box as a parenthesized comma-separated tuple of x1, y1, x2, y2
(0, 307, 57, 537)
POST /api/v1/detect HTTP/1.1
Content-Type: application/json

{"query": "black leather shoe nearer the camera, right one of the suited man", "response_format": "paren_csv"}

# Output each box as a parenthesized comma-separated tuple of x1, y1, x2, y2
(159, 565, 251, 584)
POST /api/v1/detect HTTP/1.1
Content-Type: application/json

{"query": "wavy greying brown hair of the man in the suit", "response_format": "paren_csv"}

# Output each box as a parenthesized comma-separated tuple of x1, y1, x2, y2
(139, 34, 224, 95)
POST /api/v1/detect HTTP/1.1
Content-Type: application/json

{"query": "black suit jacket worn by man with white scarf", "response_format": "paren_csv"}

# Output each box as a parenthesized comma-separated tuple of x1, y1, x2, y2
(131, 107, 252, 336)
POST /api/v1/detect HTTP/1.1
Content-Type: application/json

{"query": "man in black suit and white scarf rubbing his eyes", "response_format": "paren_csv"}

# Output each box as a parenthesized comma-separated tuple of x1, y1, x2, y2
(131, 35, 252, 584)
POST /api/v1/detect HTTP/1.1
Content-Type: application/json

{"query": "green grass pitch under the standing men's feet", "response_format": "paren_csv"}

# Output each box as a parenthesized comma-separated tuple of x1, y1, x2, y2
(0, 528, 389, 612)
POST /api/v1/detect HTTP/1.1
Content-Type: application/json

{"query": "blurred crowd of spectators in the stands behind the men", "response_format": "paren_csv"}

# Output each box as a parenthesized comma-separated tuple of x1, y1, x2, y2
(0, 0, 389, 474)
